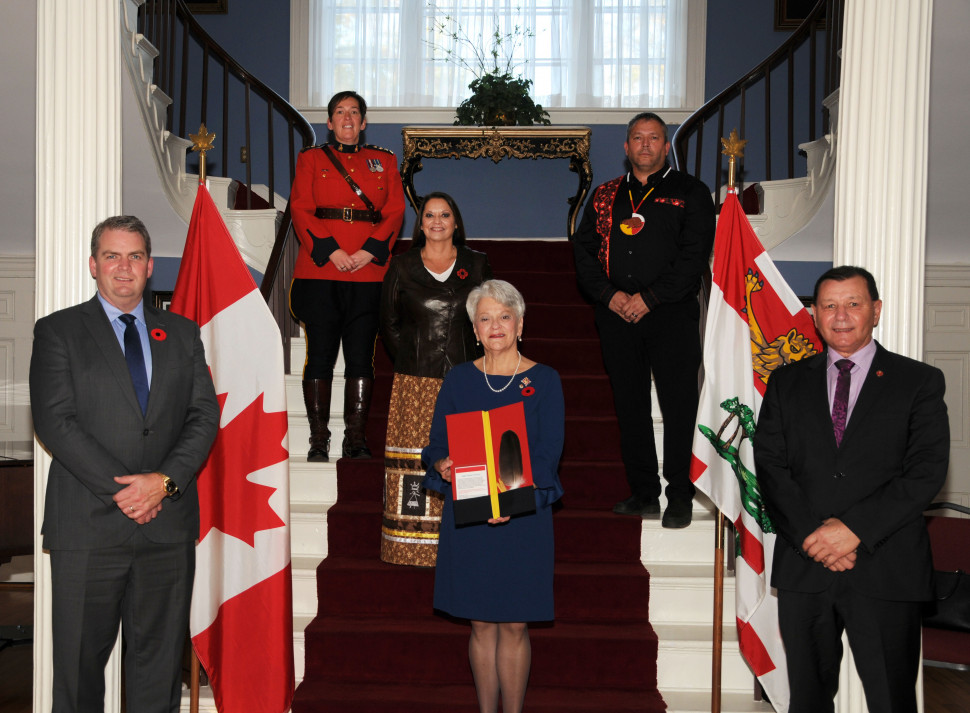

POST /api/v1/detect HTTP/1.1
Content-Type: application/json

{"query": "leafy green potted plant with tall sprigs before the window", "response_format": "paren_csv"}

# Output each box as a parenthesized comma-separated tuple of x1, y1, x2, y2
(428, 6, 551, 126)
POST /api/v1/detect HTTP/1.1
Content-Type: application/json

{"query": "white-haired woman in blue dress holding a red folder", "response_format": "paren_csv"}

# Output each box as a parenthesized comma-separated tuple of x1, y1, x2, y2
(422, 280, 565, 713)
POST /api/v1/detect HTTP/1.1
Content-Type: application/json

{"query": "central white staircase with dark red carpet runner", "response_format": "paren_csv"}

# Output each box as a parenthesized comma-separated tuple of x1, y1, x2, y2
(200, 241, 771, 713)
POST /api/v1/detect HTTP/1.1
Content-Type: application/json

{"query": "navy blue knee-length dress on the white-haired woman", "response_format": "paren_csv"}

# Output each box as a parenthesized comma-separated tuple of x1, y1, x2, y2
(421, 362, 565, 622)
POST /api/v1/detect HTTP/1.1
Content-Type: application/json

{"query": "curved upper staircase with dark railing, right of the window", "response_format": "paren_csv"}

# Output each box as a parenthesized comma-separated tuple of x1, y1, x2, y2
(670, 0, 845, 250)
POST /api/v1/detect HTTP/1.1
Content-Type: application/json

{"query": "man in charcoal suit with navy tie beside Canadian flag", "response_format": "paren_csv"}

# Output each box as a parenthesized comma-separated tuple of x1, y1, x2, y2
(30, 216, 219, 713)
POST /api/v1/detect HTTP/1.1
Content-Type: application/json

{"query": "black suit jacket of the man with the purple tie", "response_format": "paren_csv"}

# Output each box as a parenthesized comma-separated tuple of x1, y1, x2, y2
(754, 344, 950, 601)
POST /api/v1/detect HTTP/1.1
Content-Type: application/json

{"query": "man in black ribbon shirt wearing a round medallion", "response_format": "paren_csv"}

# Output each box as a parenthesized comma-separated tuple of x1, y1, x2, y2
(573, 112, 714, 528)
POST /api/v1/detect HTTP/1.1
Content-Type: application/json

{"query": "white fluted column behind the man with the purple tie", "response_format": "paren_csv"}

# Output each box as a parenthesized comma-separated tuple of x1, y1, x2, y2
(833, 0, 933, 713)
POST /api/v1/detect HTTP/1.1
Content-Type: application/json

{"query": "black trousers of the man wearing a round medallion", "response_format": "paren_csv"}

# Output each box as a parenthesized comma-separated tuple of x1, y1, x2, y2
(596, 299, 701, 500)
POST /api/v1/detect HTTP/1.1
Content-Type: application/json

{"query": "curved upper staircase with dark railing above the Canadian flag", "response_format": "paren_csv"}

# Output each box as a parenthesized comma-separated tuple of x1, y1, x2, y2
(121, 0, 314, 272)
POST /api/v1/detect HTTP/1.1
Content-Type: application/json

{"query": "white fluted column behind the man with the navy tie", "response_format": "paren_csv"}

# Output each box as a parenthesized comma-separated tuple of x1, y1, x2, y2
(34, 0, 121, 713)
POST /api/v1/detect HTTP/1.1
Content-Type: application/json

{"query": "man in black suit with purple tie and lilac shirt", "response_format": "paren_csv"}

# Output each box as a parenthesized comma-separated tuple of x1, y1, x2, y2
(754, 266, 950, 713)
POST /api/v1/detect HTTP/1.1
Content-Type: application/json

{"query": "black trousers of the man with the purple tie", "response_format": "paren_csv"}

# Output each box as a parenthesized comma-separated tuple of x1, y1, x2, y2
(778, 576, 921, 713)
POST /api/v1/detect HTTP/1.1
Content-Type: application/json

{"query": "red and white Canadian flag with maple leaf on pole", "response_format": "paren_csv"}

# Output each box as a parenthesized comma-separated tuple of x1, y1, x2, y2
(171, 186, 294, 713)
